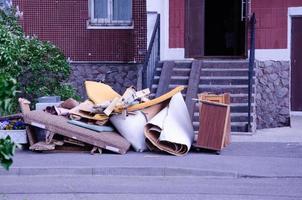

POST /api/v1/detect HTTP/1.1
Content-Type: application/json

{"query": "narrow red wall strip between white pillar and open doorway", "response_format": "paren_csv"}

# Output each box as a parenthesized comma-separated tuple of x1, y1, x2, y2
(169, 0, 185, 48)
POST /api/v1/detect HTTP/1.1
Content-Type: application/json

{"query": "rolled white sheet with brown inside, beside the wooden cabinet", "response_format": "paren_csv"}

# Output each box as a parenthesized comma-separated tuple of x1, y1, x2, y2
(144, 92, 194, 156)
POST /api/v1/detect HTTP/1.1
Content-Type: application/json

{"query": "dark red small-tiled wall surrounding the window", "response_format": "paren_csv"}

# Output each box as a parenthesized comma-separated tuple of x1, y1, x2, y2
(13, 0, 147, 62)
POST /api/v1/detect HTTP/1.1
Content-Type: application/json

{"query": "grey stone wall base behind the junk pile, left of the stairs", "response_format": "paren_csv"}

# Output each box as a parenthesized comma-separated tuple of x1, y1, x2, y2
(69, 63, 140, 99)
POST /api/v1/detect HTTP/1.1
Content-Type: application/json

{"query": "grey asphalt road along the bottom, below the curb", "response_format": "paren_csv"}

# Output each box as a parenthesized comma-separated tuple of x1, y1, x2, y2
(0, 176, 302, 200)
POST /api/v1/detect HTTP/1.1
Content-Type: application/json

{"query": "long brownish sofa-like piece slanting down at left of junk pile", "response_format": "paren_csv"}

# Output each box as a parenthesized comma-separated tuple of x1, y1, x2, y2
(19, 99, 130, 154)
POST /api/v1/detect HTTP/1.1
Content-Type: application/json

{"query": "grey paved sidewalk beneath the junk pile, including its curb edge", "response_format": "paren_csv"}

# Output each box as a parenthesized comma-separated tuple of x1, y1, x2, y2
(0, 115, 302, 178)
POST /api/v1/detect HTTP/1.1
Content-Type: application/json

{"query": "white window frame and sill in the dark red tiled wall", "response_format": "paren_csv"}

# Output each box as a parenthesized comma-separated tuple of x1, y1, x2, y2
(87, 0, 133, 29)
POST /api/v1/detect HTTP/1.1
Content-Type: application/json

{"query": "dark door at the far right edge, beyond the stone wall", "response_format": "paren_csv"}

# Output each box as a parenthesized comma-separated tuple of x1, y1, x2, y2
(291, 17, 302, 111)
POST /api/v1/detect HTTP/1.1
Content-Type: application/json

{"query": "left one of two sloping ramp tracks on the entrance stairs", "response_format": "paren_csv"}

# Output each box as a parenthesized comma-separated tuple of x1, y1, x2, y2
(156, 61, 175, 97)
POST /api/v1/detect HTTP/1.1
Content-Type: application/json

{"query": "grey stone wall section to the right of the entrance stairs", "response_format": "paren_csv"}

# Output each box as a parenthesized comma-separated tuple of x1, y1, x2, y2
(255, 61, 290, 129)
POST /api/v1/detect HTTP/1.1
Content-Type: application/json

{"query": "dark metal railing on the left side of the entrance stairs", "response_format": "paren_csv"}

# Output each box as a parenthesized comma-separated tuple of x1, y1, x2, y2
(142, 14, 160, 89)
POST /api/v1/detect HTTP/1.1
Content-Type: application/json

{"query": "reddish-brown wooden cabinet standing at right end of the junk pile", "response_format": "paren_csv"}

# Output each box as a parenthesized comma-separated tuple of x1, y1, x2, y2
(194, 100, 230, 153)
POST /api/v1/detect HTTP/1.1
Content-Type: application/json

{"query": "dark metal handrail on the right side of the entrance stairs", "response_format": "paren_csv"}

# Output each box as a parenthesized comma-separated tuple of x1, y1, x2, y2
(247, 13, 256, 132)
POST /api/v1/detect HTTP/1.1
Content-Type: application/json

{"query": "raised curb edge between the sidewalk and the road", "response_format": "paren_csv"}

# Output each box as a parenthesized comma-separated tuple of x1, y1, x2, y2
(0, 167, 238, 178)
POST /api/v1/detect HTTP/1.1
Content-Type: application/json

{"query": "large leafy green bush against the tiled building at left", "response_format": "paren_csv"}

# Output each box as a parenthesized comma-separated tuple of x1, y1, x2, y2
(0, 9, 79, 111)
